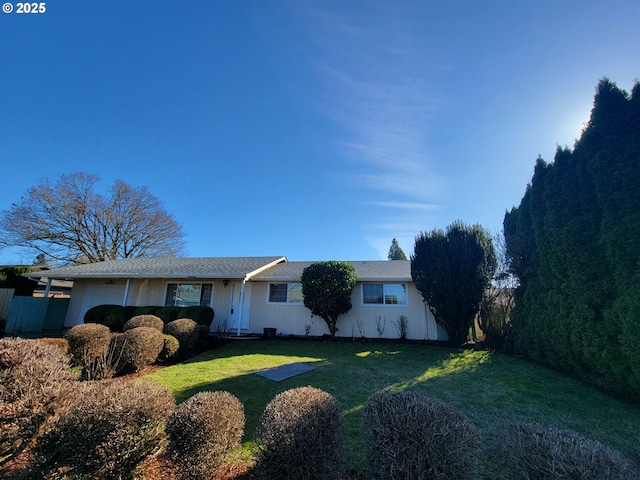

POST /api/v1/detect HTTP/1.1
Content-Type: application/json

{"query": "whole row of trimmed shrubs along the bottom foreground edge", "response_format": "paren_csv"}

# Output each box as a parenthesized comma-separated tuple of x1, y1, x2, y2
(0, 342, 637, 480)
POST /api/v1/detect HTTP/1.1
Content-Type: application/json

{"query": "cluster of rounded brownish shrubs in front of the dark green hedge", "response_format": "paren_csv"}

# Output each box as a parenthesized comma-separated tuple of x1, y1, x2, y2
(65, 315, 201, 380)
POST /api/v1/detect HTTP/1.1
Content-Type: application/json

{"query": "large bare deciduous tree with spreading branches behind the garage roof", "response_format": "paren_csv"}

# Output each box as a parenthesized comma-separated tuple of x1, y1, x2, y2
(0, 173, 184, 264)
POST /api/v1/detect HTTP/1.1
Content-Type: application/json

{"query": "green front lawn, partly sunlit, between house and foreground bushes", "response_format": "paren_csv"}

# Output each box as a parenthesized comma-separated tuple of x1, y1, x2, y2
(145, 340, 640, 475)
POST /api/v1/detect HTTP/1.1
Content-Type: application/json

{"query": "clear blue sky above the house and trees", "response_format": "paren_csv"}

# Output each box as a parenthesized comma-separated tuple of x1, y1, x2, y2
(0, 0, 640, 264)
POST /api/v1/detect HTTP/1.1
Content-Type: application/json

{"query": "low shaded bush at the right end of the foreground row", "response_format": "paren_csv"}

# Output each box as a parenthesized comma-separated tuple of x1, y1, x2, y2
(499, 423, 638, 480)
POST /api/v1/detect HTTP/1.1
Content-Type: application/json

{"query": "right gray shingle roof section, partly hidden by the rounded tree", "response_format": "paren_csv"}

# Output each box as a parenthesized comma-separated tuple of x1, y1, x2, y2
(251, 260, 411, 282)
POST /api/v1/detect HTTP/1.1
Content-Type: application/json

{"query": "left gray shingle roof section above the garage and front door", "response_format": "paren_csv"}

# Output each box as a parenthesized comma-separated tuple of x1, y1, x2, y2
(30, 257, 286, 280)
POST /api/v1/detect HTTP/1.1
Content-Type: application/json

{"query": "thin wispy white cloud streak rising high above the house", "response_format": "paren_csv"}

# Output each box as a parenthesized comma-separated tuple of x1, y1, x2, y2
(290, 3, 447, 258)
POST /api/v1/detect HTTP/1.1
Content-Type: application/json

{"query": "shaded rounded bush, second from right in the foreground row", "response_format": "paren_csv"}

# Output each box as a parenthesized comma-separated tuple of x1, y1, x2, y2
(363, 392, 480, 480)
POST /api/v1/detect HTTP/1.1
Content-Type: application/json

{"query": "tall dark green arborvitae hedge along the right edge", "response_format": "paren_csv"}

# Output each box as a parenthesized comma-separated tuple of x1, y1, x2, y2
(504, 79, 640, 392)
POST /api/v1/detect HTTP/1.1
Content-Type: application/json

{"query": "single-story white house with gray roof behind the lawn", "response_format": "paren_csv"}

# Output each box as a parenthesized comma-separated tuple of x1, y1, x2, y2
(26, 256, 446, 340)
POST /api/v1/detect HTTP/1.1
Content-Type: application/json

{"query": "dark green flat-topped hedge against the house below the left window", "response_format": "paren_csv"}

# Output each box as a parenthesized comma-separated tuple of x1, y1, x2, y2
(84, 305, 214, 332)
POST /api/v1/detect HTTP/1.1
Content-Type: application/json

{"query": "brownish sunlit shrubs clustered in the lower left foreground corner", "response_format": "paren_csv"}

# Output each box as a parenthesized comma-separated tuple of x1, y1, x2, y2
(0, 340, 244, 480)
